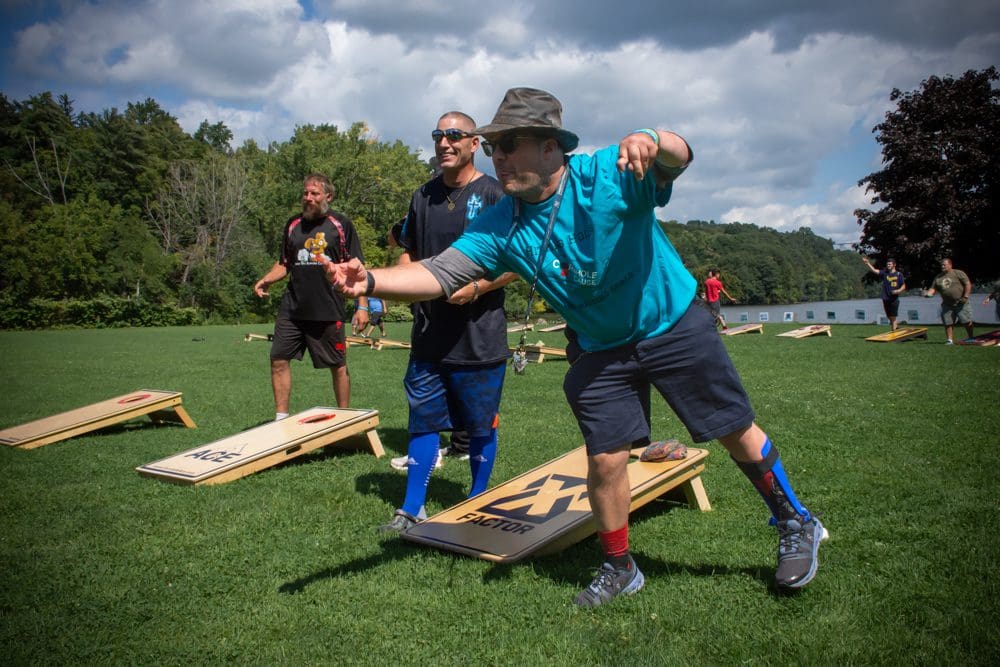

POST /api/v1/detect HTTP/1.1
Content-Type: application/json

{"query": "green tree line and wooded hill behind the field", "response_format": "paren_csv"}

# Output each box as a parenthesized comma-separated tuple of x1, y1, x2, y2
(9, 77, 995, 329)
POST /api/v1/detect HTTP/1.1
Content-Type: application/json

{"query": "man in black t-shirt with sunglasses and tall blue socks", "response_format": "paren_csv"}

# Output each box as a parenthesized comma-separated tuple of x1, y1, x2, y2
(383, 111, 515, 532)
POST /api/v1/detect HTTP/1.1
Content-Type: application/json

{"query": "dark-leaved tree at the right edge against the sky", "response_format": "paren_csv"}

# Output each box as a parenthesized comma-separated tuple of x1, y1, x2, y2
(854, 67, 1000, 285)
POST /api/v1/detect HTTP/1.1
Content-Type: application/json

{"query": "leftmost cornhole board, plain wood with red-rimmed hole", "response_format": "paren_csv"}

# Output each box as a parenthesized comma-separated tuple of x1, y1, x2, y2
(0, 389, 196, 449)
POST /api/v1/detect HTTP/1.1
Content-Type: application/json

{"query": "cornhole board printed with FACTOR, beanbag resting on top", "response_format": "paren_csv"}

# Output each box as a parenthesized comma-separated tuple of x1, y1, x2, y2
(402, 447, 712, 563)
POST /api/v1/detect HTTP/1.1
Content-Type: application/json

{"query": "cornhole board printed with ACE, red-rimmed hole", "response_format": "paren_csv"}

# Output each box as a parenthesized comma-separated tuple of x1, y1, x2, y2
(136, 406, 385, 485)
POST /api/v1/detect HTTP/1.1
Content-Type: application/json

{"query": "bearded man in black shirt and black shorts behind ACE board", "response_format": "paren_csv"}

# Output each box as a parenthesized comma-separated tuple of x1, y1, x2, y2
(253, 174, 368, 419)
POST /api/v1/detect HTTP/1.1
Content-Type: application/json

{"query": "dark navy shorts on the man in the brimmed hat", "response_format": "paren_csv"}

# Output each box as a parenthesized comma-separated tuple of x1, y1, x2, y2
(563, 304, 754, 455)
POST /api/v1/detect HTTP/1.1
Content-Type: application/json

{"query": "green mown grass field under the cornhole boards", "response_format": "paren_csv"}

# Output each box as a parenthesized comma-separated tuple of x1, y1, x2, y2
(0, 325, 1000, 665)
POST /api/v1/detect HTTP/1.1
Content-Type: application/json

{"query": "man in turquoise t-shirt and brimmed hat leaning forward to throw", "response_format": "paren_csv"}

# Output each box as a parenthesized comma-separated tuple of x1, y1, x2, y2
(326, 88, 827, 607)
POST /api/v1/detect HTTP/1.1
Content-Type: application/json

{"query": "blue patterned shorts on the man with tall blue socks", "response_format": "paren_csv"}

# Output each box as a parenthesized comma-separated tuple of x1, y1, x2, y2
(403, 359, 507, 437)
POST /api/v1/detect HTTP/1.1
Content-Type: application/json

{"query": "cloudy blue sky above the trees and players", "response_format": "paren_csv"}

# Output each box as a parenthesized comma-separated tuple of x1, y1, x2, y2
(0, 0, 1000, 243)
